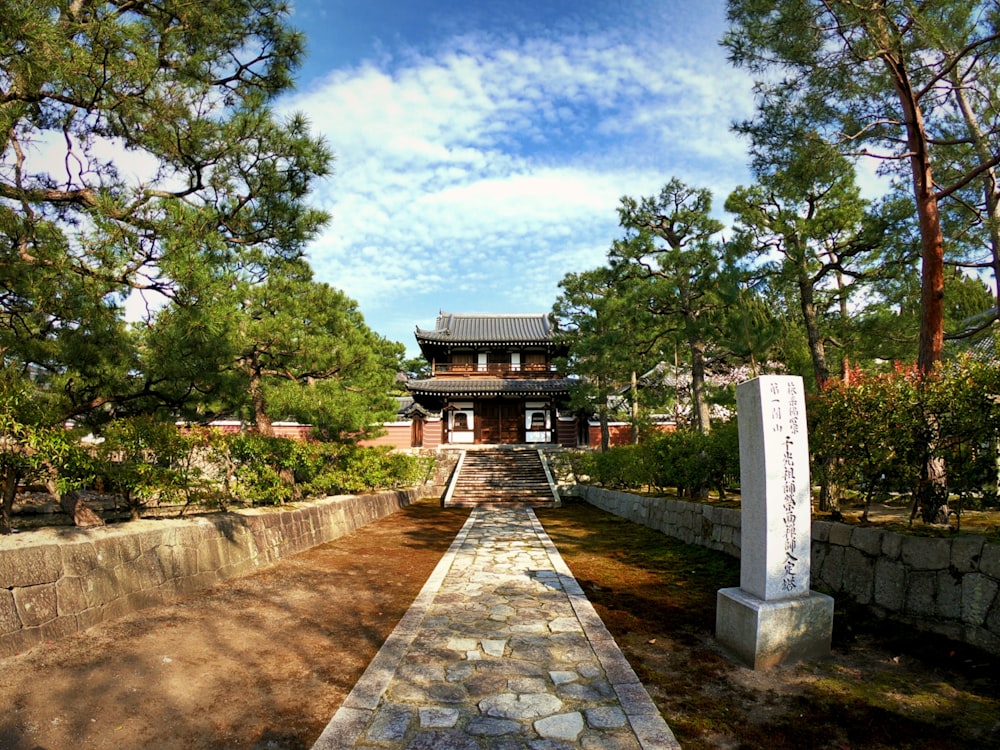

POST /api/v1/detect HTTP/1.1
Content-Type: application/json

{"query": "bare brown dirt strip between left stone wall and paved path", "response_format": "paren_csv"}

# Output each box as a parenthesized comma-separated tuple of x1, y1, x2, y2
(0, 502, 468, 750)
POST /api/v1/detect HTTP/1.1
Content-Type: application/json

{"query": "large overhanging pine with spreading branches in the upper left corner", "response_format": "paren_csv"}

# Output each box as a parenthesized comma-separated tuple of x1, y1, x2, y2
(0, 0, 331, 418)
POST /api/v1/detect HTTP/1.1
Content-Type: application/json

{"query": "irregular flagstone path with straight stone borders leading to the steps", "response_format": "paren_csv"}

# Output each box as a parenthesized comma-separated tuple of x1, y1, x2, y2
(313, 508, 680, 750)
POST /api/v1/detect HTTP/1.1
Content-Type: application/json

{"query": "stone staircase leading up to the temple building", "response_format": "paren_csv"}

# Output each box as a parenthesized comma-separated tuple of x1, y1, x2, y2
(444, 448, 559, 508)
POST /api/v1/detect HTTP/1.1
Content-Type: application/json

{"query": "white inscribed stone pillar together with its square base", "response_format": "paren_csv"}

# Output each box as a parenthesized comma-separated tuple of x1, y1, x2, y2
(715, 375, 833, 669)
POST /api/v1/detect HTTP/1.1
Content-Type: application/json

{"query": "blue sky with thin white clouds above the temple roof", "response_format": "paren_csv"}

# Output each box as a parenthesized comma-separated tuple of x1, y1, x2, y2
(281, 0, 752, 354)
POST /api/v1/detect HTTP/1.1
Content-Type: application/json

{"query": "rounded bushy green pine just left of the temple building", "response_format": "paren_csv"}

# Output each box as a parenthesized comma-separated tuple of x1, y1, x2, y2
(143, 274, 404, 440)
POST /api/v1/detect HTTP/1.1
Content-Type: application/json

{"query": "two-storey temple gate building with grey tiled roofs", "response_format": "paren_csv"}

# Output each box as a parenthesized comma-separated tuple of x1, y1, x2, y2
(405, 312, 577, 447)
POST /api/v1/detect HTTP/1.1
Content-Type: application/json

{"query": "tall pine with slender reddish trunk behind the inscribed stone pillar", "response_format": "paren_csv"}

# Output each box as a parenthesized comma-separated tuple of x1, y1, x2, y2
(724, 0, 1000, 370)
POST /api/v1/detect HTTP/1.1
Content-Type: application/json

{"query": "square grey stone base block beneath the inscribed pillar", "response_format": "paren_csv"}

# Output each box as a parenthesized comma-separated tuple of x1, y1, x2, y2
(715, 588, 833, 670)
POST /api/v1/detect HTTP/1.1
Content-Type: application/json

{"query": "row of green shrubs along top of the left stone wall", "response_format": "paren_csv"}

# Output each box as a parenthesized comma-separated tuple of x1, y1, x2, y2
(0, 414, 434, 533)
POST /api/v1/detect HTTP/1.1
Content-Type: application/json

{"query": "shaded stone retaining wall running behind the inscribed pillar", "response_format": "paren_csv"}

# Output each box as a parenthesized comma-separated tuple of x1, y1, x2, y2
(561, 485, 1000, 654)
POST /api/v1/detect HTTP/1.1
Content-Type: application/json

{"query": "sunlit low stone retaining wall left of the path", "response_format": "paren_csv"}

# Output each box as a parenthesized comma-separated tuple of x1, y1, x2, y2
(0, 489, 424, 657)
